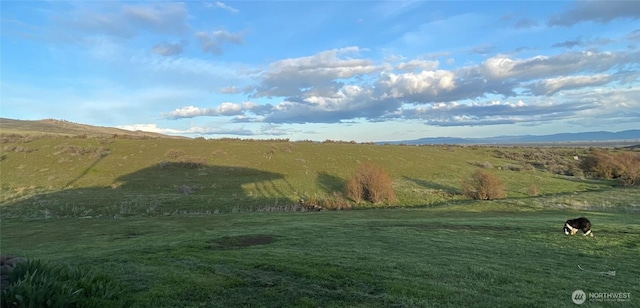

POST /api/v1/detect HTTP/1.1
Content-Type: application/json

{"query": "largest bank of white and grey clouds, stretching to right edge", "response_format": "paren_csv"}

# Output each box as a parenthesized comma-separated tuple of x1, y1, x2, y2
(159, 47, 637, 126)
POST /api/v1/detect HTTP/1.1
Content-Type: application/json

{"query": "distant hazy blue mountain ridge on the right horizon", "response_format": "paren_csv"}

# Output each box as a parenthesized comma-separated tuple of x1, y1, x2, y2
(378, 129, 640, 145)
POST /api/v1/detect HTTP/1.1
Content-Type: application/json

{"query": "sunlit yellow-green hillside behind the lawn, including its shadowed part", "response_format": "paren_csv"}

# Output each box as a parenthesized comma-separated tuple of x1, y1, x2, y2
(0, 138, 624, 218)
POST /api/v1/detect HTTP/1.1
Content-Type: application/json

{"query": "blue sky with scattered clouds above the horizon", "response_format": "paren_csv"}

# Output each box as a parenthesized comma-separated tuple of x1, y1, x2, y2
(0, 0, 640, 142)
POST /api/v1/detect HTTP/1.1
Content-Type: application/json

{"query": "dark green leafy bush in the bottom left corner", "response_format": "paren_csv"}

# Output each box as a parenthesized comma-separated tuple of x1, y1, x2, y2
(0, 260, 124, 307)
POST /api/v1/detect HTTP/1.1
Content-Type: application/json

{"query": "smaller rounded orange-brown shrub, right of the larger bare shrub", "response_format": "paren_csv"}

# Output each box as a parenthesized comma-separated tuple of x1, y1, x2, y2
(462, 170, 507, 200)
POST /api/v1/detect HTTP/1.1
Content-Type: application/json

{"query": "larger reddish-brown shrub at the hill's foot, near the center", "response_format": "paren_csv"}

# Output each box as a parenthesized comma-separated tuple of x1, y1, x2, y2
(346, 163, 396, 204)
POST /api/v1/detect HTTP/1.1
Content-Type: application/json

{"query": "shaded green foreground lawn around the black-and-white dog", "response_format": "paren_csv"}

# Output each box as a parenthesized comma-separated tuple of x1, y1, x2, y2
(1, 202, 640, 307)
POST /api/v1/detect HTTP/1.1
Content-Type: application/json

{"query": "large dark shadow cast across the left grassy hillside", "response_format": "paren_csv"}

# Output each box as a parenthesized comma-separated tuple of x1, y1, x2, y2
(2, 162, 296, 218)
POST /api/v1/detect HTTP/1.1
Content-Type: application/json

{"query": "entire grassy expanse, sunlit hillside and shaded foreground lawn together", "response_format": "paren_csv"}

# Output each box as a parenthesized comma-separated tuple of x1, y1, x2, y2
(0, 134, 640, 307)
